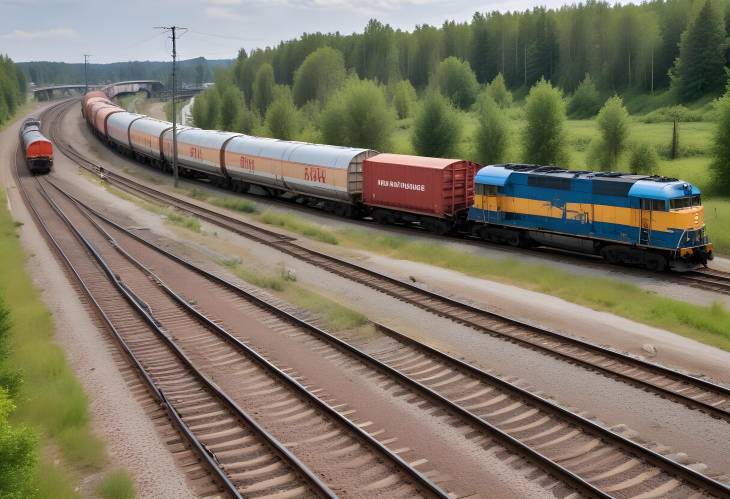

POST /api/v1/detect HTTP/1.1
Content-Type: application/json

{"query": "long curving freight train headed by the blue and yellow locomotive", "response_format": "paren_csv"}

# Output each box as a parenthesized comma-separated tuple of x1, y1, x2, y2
(82, 92, 713, 271)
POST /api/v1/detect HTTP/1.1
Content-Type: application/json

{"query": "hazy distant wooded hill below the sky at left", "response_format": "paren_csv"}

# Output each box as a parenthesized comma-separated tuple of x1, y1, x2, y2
(16, 57, 234, 86)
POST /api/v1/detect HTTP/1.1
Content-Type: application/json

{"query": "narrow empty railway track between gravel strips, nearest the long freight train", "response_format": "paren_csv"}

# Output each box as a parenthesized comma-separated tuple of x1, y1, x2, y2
(44, 96, 730, 421)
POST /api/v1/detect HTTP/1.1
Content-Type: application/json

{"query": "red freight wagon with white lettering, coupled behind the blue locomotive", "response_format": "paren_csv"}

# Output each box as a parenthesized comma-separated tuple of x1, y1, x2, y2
(362, 154, 478, 232)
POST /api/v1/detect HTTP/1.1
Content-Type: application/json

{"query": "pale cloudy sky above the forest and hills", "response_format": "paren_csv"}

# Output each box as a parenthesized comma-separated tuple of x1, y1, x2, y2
(0, 0, 568, 63)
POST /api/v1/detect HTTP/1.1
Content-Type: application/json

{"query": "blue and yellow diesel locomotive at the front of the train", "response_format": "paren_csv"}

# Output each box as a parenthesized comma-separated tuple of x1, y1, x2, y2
(468, 164, 712, 270)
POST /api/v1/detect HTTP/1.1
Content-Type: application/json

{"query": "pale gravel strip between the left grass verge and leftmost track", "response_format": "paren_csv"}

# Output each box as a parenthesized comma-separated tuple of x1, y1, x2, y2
(0, 102, 195, 498)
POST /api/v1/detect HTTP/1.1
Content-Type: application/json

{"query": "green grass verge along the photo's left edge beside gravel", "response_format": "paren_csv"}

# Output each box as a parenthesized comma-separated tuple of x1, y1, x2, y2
(0, 193, 113, 490)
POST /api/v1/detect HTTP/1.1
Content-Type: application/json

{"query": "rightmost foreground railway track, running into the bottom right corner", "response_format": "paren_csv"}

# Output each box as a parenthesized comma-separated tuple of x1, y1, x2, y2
(51, 185, 730, 497)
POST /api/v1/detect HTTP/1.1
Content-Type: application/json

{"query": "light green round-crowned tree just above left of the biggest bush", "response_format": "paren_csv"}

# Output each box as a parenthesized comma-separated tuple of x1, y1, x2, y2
(294, 47, 347, 107)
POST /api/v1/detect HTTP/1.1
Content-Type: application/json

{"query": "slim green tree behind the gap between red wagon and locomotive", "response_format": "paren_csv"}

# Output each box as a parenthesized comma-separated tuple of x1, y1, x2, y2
(474, 92, 509, 165)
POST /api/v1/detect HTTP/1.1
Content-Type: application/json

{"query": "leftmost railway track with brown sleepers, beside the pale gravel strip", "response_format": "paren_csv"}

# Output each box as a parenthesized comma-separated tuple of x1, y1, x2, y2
(16, 144, 335, 497)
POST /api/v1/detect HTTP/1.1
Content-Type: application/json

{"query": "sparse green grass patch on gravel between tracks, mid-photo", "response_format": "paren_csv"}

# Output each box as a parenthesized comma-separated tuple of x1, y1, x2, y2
(219, 258, 368, 332)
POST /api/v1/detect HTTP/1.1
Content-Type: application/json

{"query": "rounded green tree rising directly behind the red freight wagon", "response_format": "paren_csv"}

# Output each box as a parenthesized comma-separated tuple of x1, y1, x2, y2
(411, 92, 462, 158)
